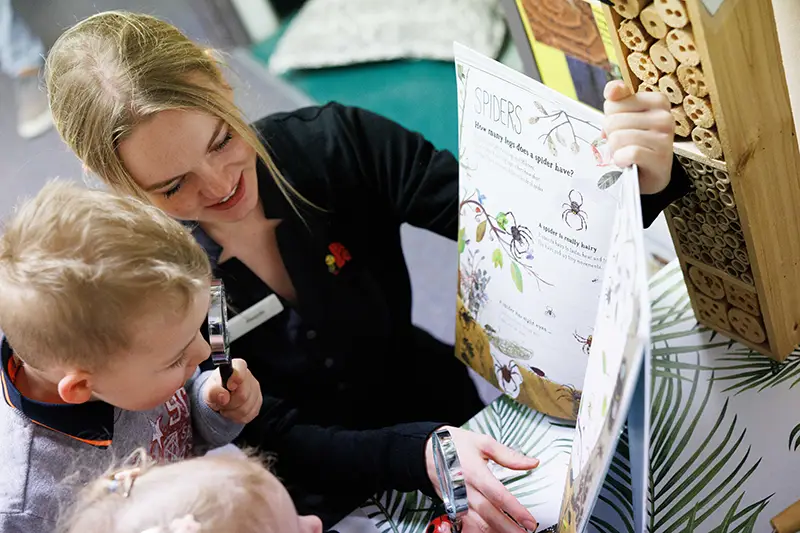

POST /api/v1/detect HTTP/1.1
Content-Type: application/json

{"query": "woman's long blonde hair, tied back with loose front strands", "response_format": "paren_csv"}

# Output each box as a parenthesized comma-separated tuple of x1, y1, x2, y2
(45, 11, 310, 210)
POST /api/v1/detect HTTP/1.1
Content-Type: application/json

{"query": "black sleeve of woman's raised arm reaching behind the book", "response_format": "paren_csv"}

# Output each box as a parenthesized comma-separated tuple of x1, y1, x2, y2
(318, 104, 689, 235)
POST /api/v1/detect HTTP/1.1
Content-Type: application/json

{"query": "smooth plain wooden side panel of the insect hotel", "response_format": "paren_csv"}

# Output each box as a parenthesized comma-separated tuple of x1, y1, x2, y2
(687, 0, 800, 355)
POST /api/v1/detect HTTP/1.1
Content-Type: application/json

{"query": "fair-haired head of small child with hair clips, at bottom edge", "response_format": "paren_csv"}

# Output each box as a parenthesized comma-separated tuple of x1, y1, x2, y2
(62, 451, 322, 533)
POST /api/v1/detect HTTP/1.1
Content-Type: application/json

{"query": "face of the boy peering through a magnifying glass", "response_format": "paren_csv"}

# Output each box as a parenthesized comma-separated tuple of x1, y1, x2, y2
(92, 288, 211, 411)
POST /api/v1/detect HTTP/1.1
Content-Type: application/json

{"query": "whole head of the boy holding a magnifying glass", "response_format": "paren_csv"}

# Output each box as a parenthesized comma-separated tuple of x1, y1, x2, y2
(0, 181, 211, 410)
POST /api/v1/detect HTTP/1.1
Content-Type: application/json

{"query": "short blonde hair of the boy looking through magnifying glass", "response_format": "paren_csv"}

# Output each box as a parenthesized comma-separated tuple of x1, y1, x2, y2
(0, 181, 211, 370)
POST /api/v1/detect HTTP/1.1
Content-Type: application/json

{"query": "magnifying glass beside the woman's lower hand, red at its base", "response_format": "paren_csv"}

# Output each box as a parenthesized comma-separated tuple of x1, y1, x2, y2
(428, 429, 469, 533)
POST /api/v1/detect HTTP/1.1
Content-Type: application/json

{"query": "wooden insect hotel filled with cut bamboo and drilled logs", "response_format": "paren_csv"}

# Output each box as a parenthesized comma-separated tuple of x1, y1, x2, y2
(604, 0, 800, 360)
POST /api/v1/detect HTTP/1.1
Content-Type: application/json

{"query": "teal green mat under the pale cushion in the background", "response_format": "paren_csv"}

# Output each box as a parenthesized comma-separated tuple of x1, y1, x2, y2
(251, 27, 458, 154)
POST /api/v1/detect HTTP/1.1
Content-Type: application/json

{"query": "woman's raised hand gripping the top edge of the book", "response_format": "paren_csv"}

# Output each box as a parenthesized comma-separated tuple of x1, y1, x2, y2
(603, 80, 675, 194)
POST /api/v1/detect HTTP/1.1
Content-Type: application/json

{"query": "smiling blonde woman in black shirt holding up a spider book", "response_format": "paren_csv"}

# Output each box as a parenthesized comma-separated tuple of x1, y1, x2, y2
(46, 12, 687, 533)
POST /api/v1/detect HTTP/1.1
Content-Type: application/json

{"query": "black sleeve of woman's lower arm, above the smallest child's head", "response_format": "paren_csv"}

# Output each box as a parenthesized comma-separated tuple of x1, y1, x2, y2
(240, 397, 444, 497)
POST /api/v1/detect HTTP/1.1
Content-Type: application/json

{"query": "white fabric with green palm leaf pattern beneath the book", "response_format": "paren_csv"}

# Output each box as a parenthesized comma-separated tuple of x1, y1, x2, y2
(362, 262, 800, 533)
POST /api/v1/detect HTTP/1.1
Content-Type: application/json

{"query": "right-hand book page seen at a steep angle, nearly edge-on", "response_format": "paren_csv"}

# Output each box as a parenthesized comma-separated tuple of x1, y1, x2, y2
(559, 168, 650, 533)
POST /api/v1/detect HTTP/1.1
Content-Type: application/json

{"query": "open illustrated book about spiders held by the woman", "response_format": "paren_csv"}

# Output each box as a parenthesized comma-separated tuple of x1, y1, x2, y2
(455, 44, 650, 533)
